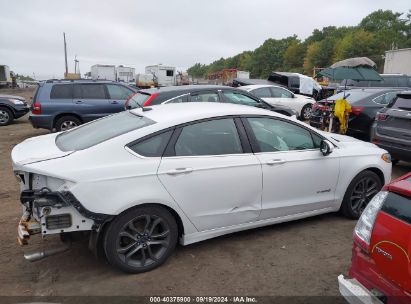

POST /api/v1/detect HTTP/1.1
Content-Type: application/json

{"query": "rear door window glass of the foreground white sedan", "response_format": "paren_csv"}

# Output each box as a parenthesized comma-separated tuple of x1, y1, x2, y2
(175, 118, 243, 156)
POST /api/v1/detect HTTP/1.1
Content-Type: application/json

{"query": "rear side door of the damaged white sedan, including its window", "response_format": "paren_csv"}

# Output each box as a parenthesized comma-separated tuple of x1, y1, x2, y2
(158, 118, 262, 231)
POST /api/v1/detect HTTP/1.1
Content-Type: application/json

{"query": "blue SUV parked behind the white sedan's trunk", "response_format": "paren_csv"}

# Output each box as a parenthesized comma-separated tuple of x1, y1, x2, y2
(29, 80, 137, 131)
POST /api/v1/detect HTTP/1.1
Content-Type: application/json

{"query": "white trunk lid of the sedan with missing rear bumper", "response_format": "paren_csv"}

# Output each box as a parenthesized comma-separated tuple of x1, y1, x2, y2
(11, 133, 73, 170)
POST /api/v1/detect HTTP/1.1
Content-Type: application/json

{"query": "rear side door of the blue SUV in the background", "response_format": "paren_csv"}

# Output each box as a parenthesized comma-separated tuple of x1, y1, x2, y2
(73, 83, 113, 122)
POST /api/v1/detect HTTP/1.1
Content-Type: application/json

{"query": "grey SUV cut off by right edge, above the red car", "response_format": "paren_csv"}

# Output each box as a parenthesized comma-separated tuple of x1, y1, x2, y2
(371, 91, 411, 161)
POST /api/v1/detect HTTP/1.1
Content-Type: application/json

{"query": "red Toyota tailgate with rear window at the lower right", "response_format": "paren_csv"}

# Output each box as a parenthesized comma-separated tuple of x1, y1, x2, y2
(370, 177, 411, 292)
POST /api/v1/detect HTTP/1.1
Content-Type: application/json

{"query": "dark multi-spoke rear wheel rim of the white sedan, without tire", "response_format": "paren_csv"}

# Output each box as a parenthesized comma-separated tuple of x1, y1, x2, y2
(116, 215, 170, 267)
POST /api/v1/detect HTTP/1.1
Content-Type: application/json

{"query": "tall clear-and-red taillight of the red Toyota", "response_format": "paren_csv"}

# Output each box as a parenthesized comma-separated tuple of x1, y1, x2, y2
(354, 191, 388, 252)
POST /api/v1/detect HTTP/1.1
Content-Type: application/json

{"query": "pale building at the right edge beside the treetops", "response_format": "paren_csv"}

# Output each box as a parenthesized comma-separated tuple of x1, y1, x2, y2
(384, 48, 411, 75)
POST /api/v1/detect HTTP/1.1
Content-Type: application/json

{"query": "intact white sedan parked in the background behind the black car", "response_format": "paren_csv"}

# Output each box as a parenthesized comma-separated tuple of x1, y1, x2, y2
(239, 84, 315, 120)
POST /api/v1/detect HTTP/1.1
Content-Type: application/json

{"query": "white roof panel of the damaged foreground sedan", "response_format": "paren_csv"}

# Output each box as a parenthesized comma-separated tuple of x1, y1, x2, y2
(130, 102, 282, 127)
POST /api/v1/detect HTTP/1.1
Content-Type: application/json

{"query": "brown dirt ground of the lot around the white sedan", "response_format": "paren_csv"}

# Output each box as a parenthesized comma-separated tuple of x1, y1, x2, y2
(0, 90, 411, 296)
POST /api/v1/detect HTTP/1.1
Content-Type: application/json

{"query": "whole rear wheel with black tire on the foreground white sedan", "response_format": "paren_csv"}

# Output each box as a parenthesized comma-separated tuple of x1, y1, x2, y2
(104, 206, 178, 273)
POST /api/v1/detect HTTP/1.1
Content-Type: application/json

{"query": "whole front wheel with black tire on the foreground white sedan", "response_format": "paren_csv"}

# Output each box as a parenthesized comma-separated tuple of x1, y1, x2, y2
(340, 170, 382, 219)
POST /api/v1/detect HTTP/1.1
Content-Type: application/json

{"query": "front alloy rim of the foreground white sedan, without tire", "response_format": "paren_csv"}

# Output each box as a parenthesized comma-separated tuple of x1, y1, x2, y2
(350, 177, 379, 215)
